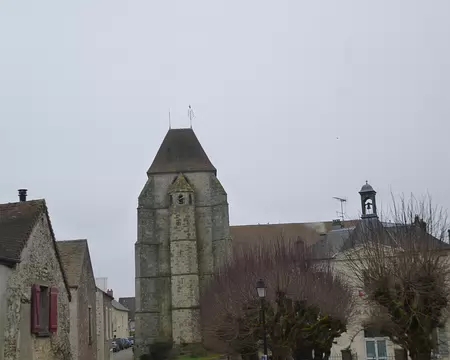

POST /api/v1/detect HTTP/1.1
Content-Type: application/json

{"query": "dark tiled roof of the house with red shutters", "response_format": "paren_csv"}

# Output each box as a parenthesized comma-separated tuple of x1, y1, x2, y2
(0, 200, 45, 262)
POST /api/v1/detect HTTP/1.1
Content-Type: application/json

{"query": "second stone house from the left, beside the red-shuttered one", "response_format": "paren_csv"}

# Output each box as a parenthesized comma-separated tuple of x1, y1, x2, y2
(57, 240, 97, 360)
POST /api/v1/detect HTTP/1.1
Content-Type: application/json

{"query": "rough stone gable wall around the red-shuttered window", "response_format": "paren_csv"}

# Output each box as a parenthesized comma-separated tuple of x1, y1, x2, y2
(4, 215, 72, 360)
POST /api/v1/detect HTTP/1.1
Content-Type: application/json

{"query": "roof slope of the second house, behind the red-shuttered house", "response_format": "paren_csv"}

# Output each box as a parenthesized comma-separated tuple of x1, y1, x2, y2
(56, 239, 89, 287)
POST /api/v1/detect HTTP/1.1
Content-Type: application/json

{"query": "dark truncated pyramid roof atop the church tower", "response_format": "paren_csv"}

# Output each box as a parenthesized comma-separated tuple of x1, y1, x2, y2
(147, 128, 217, 174)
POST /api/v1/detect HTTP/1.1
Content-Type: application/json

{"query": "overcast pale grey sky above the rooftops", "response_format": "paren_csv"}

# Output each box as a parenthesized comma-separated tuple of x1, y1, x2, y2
(0, 0, 450, 296)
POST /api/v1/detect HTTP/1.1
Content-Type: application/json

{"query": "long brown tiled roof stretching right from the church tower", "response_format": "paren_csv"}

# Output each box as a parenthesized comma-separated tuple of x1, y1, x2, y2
(230, 220, 358, 246)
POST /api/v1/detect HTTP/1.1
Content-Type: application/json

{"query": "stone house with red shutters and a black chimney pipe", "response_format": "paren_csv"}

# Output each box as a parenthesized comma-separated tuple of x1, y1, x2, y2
(0, 190, 72, 360)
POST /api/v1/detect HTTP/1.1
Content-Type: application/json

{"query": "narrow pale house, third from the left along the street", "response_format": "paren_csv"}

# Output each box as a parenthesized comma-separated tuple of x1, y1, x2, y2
(96, 288, 114, 360)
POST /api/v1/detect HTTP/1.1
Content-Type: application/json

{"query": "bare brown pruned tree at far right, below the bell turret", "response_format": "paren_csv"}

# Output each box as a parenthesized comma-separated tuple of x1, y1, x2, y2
(346, 197, 450, 360)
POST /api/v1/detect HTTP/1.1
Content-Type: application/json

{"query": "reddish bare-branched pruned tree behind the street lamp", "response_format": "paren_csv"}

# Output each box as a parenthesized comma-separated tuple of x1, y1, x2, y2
(201, 237, 353, 359)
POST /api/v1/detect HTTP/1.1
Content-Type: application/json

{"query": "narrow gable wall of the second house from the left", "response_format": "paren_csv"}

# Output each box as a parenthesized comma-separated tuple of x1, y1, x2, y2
(74, 250, 97, 360)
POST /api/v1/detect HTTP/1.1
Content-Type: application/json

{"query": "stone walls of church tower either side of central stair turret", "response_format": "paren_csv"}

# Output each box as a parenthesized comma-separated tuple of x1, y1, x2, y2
(135, 172, 231, 358)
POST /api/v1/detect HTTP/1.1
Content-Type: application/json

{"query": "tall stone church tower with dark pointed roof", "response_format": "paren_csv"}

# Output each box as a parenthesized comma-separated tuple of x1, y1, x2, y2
(135, 128, 231, 358)
